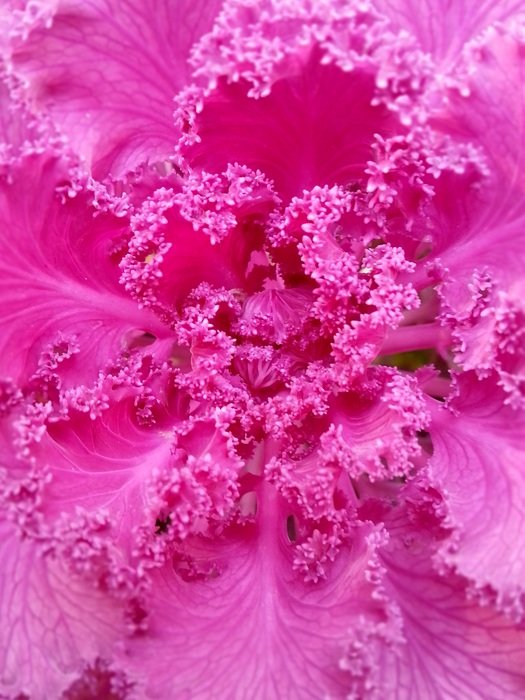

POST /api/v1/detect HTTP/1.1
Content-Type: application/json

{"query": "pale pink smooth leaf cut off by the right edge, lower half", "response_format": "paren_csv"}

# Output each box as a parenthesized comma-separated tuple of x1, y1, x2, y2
(430, 373, 525, 616)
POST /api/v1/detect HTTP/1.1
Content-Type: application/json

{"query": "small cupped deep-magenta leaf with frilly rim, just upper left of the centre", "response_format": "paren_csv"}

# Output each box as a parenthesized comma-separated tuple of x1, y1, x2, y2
(120, 165, 278, 315)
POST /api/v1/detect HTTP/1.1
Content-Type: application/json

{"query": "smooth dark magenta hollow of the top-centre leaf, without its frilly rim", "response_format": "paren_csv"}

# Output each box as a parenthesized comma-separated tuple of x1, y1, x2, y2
(178, 60, 399, 198)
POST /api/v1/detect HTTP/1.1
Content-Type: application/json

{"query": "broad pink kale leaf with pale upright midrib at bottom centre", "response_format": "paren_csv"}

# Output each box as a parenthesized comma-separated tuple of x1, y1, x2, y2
(116, 485, 390, 700)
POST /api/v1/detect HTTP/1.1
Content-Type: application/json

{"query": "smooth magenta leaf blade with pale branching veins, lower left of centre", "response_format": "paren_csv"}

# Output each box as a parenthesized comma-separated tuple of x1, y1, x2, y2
(37, 399, 171, 528)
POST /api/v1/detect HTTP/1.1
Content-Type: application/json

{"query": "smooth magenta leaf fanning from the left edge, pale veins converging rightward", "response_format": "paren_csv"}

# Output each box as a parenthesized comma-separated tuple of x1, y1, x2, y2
(0, 150, 165, 385)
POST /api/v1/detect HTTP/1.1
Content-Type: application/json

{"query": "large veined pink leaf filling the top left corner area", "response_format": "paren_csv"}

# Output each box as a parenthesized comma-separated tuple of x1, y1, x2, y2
(9, 0, 221, 177)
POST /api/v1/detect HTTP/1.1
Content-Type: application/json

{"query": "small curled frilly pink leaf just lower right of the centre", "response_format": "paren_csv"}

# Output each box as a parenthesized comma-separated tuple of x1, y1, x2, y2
(268, 368, 429, 498)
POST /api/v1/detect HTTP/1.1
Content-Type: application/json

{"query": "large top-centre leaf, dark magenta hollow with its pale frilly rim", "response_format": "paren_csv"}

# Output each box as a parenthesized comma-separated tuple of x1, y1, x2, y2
(177, 0, 427, 199)
